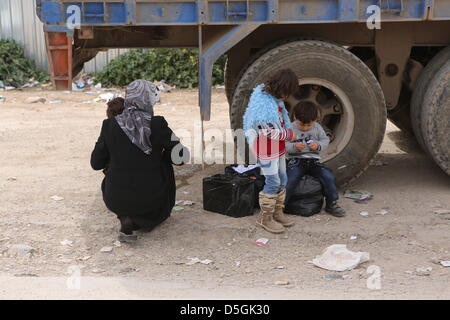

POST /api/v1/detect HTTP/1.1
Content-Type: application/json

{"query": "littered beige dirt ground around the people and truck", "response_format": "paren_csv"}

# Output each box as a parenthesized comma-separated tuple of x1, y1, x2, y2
(0, 89, 450, 299)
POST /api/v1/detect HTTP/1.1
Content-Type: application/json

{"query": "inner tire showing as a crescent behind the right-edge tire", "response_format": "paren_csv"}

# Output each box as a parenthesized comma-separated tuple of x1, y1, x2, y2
(410, 47, 450, 153)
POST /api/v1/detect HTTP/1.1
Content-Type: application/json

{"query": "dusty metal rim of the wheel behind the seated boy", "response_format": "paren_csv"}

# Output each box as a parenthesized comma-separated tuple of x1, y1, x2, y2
(286, 78, 355, 162)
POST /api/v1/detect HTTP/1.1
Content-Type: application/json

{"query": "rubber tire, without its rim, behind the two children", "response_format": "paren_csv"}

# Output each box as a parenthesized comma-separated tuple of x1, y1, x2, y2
(230, 41, 386, 185)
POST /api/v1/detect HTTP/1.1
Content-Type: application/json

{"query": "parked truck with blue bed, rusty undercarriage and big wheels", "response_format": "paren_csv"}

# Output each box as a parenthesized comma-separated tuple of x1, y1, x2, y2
(36, 0, 450, 184)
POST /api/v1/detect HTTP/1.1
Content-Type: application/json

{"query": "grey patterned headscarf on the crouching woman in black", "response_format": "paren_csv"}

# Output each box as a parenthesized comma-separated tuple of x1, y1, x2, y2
(116, 80, 160, 154)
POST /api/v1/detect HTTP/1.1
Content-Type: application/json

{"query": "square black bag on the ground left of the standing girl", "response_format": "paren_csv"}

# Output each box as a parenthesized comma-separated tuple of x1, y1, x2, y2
(203, 174, 255, 218)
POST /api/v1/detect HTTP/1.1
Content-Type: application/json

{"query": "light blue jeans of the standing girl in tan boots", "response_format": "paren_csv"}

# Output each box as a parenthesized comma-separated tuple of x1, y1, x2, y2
(258, 156, 287, 194)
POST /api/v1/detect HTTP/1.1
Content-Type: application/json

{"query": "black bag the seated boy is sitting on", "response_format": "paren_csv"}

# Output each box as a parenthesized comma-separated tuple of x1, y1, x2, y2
(284, 175, 323, 217)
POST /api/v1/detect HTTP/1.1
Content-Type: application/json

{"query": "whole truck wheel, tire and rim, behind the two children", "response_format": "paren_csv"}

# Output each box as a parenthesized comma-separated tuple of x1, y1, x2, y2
(230, 40, 386, 185)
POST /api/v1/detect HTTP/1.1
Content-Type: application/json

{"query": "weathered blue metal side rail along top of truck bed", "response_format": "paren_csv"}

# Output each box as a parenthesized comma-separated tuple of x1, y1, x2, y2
(36, 0, 450, 26)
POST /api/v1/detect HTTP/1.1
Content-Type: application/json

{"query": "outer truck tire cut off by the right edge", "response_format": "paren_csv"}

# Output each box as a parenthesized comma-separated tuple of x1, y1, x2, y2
(421, 60, 450, 175)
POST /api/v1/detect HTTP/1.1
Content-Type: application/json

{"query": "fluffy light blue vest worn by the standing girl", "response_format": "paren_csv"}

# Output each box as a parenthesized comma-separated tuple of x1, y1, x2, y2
(243, 84, 291, 146)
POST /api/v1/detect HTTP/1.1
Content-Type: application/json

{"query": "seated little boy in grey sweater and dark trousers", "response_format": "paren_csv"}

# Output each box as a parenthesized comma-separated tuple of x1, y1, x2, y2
(285, 101, 345, 217)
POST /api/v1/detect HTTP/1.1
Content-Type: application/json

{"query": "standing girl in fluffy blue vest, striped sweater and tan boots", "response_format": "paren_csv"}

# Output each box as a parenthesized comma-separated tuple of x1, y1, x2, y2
(244, 69, 298, 233)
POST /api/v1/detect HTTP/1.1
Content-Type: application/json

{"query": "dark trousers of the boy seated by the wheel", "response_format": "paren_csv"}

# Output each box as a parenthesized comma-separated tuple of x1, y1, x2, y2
(284, 158, 339, 205)
